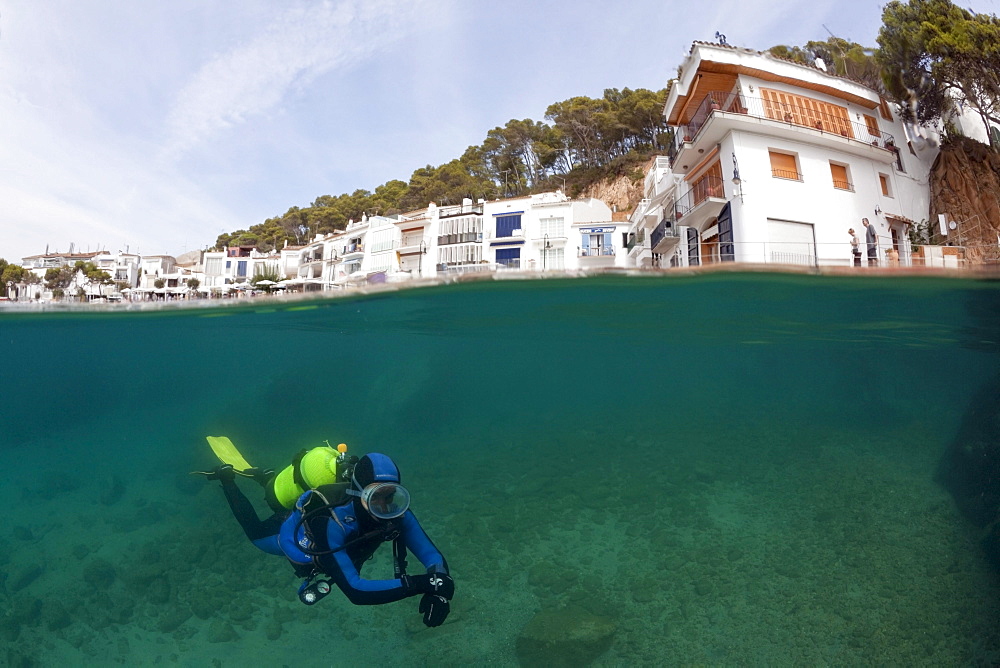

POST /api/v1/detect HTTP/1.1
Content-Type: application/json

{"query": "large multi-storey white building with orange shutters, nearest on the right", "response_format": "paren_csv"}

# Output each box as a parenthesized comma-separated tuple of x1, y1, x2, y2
(664, 42, 936, 266)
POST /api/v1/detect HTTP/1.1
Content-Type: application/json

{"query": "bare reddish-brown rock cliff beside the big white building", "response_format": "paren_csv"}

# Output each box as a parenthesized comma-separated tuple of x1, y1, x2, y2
(930, 137, 1000, 264)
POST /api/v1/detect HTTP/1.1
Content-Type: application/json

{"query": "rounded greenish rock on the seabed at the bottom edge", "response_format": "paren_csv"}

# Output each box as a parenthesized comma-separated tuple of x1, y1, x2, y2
(517, 607, 615, 666)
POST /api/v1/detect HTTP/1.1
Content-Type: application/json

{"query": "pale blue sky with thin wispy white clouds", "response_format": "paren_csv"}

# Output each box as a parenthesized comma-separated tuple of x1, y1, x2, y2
(0, 0, 1000, 263)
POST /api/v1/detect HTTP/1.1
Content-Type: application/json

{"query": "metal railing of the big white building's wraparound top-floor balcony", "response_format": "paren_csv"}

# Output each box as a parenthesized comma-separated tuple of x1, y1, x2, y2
(669, 91, 896, 161)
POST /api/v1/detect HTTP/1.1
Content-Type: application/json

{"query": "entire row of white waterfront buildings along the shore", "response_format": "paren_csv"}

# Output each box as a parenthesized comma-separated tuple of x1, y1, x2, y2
(11, 42, 996, 298)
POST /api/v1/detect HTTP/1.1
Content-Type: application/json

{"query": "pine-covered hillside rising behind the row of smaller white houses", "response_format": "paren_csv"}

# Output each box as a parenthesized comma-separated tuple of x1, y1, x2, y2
(215, 88, 670, 250)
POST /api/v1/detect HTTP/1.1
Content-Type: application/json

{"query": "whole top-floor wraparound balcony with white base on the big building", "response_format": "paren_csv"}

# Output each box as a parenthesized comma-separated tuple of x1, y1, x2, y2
(668, 91, 896, 172)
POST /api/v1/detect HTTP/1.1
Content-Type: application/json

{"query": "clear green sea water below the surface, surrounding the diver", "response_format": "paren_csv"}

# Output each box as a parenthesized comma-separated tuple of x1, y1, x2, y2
(0, 273, 1000, 666)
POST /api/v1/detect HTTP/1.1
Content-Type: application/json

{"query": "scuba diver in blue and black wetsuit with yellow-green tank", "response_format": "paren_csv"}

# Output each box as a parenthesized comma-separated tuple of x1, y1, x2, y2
(195, 437, 455, 627)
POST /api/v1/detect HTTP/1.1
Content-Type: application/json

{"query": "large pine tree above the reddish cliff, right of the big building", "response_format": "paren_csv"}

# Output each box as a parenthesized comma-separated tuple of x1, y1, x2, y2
(876, 0, 1000, 143)
